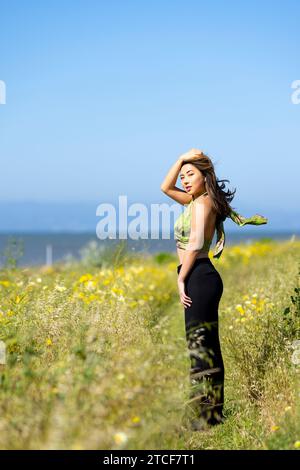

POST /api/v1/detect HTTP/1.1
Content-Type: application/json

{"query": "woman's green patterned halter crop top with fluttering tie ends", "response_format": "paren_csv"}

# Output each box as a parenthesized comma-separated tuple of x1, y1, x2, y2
(174, 192, 268, 258)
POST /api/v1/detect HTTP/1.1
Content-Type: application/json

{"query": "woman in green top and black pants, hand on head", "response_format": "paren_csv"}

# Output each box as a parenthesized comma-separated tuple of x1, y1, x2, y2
(161, 149, 267, 430)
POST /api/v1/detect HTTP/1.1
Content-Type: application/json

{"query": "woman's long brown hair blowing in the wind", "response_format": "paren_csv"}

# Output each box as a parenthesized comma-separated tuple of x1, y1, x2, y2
(181, 153, 236, 221)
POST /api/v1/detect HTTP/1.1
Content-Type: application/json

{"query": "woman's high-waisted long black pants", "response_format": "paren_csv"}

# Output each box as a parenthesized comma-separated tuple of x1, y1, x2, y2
(177, 258, 225, 424)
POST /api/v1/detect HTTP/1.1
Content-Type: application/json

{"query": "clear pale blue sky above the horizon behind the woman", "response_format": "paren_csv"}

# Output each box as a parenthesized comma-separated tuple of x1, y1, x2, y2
(0, 0, 300, 229)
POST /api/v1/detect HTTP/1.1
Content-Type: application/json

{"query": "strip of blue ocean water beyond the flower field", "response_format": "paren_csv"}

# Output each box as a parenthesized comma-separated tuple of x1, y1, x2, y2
(0, 229, 300, 267)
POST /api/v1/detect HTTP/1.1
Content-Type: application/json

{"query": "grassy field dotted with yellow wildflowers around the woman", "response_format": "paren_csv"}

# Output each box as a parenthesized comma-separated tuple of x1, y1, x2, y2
(0, 240, 300, 450)
